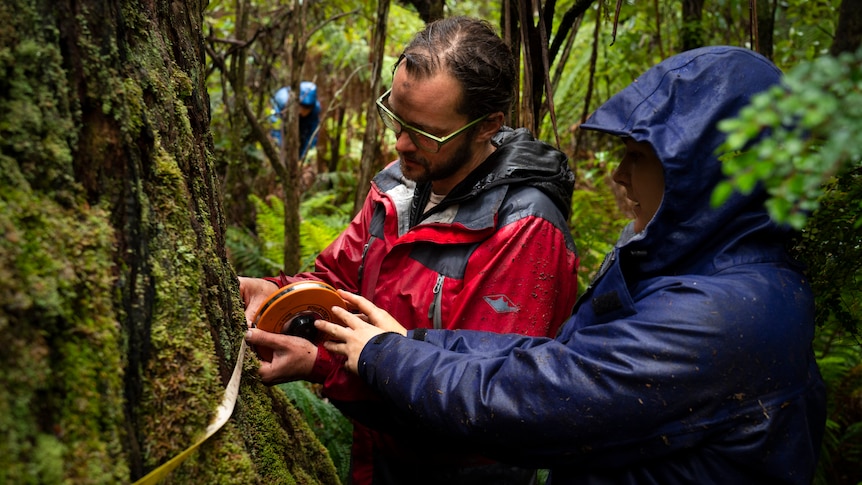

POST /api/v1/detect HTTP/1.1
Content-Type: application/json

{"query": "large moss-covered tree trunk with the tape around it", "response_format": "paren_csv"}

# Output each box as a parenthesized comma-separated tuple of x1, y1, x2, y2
(0, 0, 338, 484)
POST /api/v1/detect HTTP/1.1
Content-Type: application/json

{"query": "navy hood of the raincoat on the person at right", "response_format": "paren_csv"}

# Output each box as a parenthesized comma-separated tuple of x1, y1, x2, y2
(581, 46, 783, 273)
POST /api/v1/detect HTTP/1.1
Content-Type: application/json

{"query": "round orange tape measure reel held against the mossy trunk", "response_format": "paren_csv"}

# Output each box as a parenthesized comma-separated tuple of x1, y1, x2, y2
(253, 281, 347, 361)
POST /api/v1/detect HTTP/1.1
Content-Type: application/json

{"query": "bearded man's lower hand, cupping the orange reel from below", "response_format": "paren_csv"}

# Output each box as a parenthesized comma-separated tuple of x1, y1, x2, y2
(245, 328, 317, 385)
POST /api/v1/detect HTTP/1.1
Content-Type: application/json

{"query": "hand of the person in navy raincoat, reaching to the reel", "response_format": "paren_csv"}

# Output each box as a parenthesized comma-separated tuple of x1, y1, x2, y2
(314, 290, 407, 374)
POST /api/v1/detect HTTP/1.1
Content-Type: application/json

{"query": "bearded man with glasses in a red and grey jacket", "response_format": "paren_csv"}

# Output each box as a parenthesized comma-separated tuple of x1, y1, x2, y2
(240, 17, 578, 484)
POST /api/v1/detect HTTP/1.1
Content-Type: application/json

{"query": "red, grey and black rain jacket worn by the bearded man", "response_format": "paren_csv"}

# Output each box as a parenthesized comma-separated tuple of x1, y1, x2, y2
(271, 128, 578, 483)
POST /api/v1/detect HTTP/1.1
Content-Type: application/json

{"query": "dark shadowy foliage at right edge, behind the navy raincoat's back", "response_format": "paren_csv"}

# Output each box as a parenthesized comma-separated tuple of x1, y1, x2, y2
(793, 176, 862, 485)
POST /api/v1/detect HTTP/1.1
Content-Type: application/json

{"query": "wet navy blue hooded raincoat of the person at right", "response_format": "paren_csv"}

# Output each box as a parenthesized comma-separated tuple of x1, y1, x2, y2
(352, 47, 825, 485)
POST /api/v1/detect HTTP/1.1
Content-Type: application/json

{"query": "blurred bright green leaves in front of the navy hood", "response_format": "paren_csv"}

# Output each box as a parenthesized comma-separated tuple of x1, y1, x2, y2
(713, 51, 862, 229)
